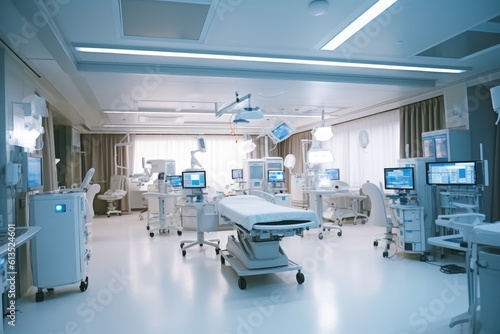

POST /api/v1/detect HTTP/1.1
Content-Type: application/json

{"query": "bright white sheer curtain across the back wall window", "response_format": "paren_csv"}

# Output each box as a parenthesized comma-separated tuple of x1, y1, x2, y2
(133, 135, 250, 191)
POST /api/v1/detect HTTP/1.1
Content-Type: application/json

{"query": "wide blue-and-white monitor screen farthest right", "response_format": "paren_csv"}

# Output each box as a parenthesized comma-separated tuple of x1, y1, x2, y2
(426, 161, 476, 186)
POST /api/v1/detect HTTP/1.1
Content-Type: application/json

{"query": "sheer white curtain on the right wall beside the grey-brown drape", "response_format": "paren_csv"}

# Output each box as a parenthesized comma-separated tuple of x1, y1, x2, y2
(321, 109, 399, 188)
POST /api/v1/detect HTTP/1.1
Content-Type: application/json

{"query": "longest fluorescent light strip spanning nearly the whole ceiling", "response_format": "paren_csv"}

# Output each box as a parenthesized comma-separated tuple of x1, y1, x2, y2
(75, 46, 466, 74)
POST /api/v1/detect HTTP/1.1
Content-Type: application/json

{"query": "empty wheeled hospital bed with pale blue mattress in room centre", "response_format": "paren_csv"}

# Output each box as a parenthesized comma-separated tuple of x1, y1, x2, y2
(218, 195, 319, 290)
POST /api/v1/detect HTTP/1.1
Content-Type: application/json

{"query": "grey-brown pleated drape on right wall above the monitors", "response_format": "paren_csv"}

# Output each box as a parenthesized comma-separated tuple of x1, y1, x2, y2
(399, 95, 445, 158)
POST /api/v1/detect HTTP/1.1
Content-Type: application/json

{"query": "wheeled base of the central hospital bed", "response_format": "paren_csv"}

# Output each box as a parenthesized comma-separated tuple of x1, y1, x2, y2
(220, 250, 305, 290)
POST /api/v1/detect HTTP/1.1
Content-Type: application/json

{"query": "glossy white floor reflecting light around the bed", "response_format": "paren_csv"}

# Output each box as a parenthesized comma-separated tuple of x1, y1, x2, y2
(4, 212, 468, 334)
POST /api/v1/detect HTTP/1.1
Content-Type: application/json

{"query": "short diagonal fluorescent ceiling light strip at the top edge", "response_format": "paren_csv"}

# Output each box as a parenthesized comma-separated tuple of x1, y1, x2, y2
(321, 0, 397, 51)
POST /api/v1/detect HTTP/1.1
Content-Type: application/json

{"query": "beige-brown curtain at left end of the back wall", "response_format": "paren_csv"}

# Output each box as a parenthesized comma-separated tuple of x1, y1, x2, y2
(81, 134, 130, 215)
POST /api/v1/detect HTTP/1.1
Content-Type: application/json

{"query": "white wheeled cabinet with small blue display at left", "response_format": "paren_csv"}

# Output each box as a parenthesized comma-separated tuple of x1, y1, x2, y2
(29, 191, 90, 302)
